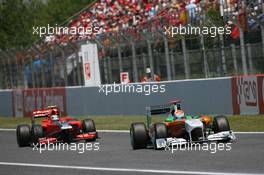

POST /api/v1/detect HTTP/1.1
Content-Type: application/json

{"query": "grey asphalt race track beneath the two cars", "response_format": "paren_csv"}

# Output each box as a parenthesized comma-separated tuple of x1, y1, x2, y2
(0, 131, 264, 175)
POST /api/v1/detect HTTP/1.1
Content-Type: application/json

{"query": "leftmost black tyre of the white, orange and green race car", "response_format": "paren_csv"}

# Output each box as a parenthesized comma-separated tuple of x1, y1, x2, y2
(130, 122, 148, 149)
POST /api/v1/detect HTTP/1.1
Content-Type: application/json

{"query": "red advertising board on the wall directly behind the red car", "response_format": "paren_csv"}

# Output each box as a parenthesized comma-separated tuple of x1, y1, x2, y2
(13, 88, 67, 117)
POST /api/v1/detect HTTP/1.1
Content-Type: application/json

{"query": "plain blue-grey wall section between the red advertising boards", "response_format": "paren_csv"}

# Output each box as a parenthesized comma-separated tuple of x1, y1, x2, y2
(66, 77, 233, 115)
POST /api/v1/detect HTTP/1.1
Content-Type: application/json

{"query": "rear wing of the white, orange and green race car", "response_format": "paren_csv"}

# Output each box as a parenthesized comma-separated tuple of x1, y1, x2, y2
(146, 104, 171, 128)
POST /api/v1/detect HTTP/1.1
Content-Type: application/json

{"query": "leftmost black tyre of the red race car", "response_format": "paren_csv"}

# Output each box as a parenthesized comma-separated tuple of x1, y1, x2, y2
(16, 125, 30, 147)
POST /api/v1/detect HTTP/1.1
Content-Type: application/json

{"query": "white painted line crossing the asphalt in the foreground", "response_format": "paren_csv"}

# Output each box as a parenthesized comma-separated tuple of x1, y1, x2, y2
(0, 162, 263, 175)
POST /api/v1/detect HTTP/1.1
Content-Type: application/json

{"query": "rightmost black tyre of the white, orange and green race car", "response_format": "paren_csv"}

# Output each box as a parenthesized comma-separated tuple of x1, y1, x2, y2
(213, 116, 230, 133)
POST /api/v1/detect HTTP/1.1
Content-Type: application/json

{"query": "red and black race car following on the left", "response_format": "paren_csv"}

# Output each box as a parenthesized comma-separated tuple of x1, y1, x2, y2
(16, 106, 97, 147)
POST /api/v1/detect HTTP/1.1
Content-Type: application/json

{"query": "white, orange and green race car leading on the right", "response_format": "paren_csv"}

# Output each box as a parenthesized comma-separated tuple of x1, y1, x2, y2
(130, 100, 235, 149)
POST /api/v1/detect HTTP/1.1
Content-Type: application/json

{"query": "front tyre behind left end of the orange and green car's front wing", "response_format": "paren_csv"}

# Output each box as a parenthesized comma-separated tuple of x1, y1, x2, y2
(153, 123, 168, 150)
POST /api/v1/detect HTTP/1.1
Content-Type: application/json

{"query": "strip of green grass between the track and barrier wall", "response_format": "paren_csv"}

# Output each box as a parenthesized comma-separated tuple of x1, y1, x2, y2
(0, 115, 264, 131)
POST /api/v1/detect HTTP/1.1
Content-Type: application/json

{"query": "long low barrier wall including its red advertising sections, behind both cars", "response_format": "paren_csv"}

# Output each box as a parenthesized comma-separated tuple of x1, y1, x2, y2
(0, 75, 264, 117)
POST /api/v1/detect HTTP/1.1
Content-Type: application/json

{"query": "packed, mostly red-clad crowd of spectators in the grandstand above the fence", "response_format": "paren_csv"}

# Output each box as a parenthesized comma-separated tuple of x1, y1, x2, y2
(44, 0, 262, 43)
